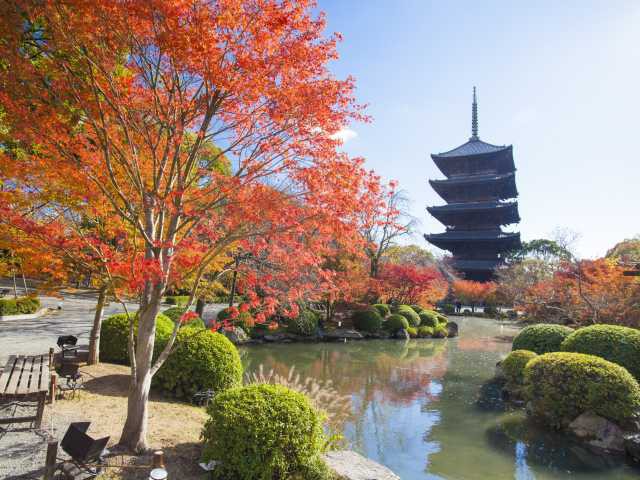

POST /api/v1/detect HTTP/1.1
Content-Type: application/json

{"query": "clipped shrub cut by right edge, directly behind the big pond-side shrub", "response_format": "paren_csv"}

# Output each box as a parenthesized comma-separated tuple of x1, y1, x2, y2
(560, 325, 640, 379)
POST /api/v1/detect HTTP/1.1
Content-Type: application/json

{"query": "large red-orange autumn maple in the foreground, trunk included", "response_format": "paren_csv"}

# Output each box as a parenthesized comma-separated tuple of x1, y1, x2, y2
(0, 0, 380, 450)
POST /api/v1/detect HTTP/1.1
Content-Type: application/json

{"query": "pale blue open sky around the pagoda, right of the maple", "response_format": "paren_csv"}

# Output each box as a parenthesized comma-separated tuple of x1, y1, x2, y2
(319, 0, 640, 257)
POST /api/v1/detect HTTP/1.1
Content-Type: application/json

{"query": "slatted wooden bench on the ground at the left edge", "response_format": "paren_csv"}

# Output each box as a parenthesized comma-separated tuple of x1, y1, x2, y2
(0, 353, 51, 428)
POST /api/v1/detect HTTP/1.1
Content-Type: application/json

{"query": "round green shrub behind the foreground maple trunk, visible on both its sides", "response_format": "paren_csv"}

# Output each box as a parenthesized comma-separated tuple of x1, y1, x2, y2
(100, 313, 174, 365)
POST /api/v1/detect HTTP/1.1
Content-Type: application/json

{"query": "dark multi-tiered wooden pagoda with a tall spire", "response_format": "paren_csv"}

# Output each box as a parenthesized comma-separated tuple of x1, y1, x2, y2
(425, 87, 520, 281)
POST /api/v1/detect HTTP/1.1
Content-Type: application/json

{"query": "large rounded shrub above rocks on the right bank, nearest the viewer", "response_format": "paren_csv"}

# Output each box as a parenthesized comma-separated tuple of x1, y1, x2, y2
(524, 352, 640, 426)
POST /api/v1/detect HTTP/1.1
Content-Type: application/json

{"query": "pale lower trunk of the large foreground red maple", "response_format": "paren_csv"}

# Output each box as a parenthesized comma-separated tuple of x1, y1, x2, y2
(120, 284, 164, 452)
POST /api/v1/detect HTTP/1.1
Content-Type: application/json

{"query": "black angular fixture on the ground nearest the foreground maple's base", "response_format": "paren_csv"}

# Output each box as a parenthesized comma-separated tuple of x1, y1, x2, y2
(60, 422, 109, 478)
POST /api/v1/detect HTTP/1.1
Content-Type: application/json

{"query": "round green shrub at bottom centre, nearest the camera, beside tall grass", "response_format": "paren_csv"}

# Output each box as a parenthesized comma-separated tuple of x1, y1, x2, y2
(202, 384, 325, 480)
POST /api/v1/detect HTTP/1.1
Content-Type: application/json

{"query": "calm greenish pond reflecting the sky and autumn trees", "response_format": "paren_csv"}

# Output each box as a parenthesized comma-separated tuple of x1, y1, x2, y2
(242, 318, 640, 480)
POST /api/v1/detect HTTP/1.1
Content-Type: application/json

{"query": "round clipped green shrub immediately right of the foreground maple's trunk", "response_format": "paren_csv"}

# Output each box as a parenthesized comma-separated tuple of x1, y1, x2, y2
(153, 328, 242, 399)
